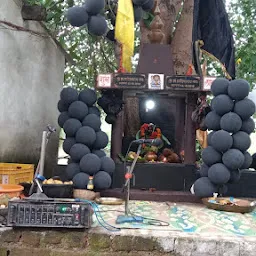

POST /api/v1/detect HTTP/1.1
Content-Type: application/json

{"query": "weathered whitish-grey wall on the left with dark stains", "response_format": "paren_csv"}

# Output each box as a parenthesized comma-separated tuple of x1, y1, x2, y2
(0, 0, 65, 176)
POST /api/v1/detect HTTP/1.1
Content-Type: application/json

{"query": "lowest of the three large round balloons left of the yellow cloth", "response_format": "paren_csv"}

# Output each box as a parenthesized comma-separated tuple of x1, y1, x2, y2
(88, 14, 108, 36)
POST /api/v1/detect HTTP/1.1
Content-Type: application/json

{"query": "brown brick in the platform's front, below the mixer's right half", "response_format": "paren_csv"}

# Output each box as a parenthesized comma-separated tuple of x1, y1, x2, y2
(61, 232, 88, 249)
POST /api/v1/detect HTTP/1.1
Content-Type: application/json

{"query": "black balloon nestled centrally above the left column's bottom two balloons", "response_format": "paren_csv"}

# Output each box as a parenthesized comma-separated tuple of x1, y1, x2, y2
(80, 154, 101, 175)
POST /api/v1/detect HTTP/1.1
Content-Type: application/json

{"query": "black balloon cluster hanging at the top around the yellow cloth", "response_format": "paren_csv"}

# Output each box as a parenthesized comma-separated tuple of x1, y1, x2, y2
(66, 0, 154, 38)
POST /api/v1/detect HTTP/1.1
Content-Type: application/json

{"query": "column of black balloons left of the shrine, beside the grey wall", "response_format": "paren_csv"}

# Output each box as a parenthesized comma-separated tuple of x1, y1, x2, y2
(58, 87, 115, 191)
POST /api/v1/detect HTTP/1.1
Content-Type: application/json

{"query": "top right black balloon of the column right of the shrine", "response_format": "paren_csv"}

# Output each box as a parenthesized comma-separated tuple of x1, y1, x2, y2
(228, 79, 250, 100)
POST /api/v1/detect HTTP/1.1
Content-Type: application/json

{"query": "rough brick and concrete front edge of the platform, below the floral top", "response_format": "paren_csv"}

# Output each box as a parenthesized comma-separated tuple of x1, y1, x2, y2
(0, 228, 256, 256)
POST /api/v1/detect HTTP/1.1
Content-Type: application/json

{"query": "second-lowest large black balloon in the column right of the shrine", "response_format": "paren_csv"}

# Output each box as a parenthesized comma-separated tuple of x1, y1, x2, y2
(208, 163, 230, 185)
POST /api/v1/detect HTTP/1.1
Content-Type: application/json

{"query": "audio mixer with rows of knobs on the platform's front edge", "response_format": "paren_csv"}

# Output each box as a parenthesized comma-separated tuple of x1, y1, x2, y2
(7, 199, 93, 228)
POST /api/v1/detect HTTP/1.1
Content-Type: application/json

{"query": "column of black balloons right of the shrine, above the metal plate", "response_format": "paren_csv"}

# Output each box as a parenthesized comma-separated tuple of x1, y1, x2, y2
(193, 78, 255, 197)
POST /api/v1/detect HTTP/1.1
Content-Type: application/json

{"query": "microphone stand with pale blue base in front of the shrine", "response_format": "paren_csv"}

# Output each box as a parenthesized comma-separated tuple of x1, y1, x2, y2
(116, 144, 143, 224)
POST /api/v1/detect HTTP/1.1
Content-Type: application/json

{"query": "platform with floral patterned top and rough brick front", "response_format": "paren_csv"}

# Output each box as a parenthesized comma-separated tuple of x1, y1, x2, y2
(0, 201, 256, 256)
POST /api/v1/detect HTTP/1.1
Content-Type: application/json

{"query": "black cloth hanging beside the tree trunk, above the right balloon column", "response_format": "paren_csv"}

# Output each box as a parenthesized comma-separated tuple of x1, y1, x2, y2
(193, 0, 235, 79)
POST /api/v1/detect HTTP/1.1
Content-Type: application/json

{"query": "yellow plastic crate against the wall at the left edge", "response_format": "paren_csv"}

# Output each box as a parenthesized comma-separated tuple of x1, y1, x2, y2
(0, 163, 34, 184)
